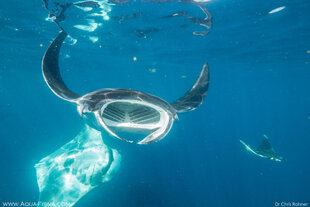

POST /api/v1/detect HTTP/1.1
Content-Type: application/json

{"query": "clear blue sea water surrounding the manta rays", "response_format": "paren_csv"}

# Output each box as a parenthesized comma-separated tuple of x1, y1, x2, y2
(0, 0, 310, 207)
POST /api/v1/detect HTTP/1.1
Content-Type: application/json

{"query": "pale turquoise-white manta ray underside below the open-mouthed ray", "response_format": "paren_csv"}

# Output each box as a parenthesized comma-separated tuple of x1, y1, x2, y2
(35, 125, 121, 207)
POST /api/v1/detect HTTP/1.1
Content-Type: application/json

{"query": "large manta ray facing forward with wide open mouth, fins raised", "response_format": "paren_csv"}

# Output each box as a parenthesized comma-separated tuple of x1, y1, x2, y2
(42, 28, 209, 144)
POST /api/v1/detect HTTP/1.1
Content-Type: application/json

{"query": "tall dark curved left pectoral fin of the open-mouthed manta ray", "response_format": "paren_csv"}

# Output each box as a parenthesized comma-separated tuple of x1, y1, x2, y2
(42, 30, 80, 102)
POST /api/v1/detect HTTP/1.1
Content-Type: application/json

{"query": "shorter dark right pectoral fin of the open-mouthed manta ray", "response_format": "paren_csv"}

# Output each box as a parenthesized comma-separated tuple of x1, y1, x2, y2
(171, 63, 209, 113)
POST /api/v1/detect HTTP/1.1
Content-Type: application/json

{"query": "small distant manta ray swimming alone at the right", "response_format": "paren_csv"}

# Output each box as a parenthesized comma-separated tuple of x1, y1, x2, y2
(240, 135, 283, 162)
